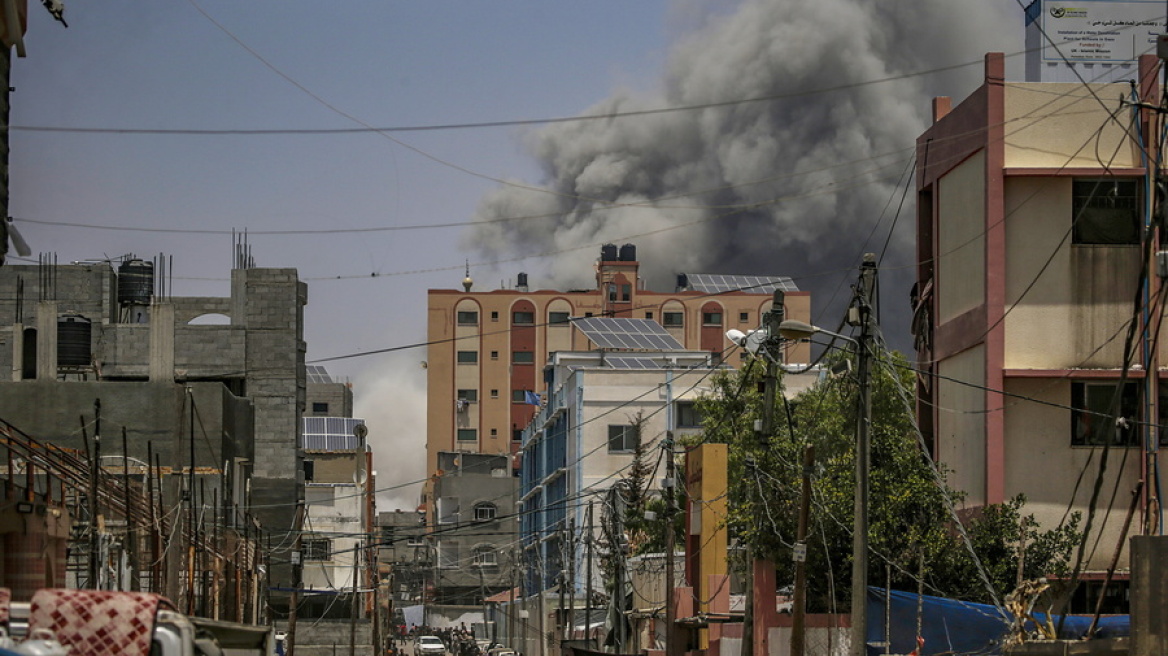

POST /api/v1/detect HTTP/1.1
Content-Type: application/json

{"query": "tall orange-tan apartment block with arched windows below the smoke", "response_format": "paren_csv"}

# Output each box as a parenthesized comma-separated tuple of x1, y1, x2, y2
(423, 244, 811, 509)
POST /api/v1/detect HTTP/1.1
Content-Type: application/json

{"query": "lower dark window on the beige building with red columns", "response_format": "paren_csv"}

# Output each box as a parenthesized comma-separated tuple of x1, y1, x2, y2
(1071, 381, 1140, 446)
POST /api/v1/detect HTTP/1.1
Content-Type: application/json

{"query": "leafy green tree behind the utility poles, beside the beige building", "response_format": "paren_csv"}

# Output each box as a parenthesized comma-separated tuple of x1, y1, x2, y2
(698, 354, 1078, 612)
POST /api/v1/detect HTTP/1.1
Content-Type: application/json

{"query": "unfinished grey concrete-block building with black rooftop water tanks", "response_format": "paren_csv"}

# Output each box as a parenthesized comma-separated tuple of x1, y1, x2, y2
(0, 258, 307, 615)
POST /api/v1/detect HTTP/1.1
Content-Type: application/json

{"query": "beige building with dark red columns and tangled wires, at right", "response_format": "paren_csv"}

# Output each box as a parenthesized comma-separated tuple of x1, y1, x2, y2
(913, 53, 1168, 610)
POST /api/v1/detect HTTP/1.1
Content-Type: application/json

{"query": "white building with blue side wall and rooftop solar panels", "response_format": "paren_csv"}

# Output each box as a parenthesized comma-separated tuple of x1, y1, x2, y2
(519, 350, 717, 595)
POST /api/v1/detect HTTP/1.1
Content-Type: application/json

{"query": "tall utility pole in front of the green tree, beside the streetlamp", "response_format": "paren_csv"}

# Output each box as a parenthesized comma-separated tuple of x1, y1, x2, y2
(850, 253, 876, 656)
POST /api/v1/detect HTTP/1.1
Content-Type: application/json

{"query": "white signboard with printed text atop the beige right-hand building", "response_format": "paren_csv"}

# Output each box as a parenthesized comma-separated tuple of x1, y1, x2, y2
(1042, 0, 1166, 62)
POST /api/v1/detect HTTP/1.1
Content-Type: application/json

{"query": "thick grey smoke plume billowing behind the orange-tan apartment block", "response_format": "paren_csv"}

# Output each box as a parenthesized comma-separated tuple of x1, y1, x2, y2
(464, 0, 1022, 349)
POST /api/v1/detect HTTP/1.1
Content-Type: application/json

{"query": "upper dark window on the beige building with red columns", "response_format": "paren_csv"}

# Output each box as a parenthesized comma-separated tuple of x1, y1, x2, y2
(1071, 177, 1143, 244)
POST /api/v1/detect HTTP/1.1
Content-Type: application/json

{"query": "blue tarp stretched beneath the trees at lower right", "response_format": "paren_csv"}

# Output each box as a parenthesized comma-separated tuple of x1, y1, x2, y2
(868, 587, 1131, 656)
